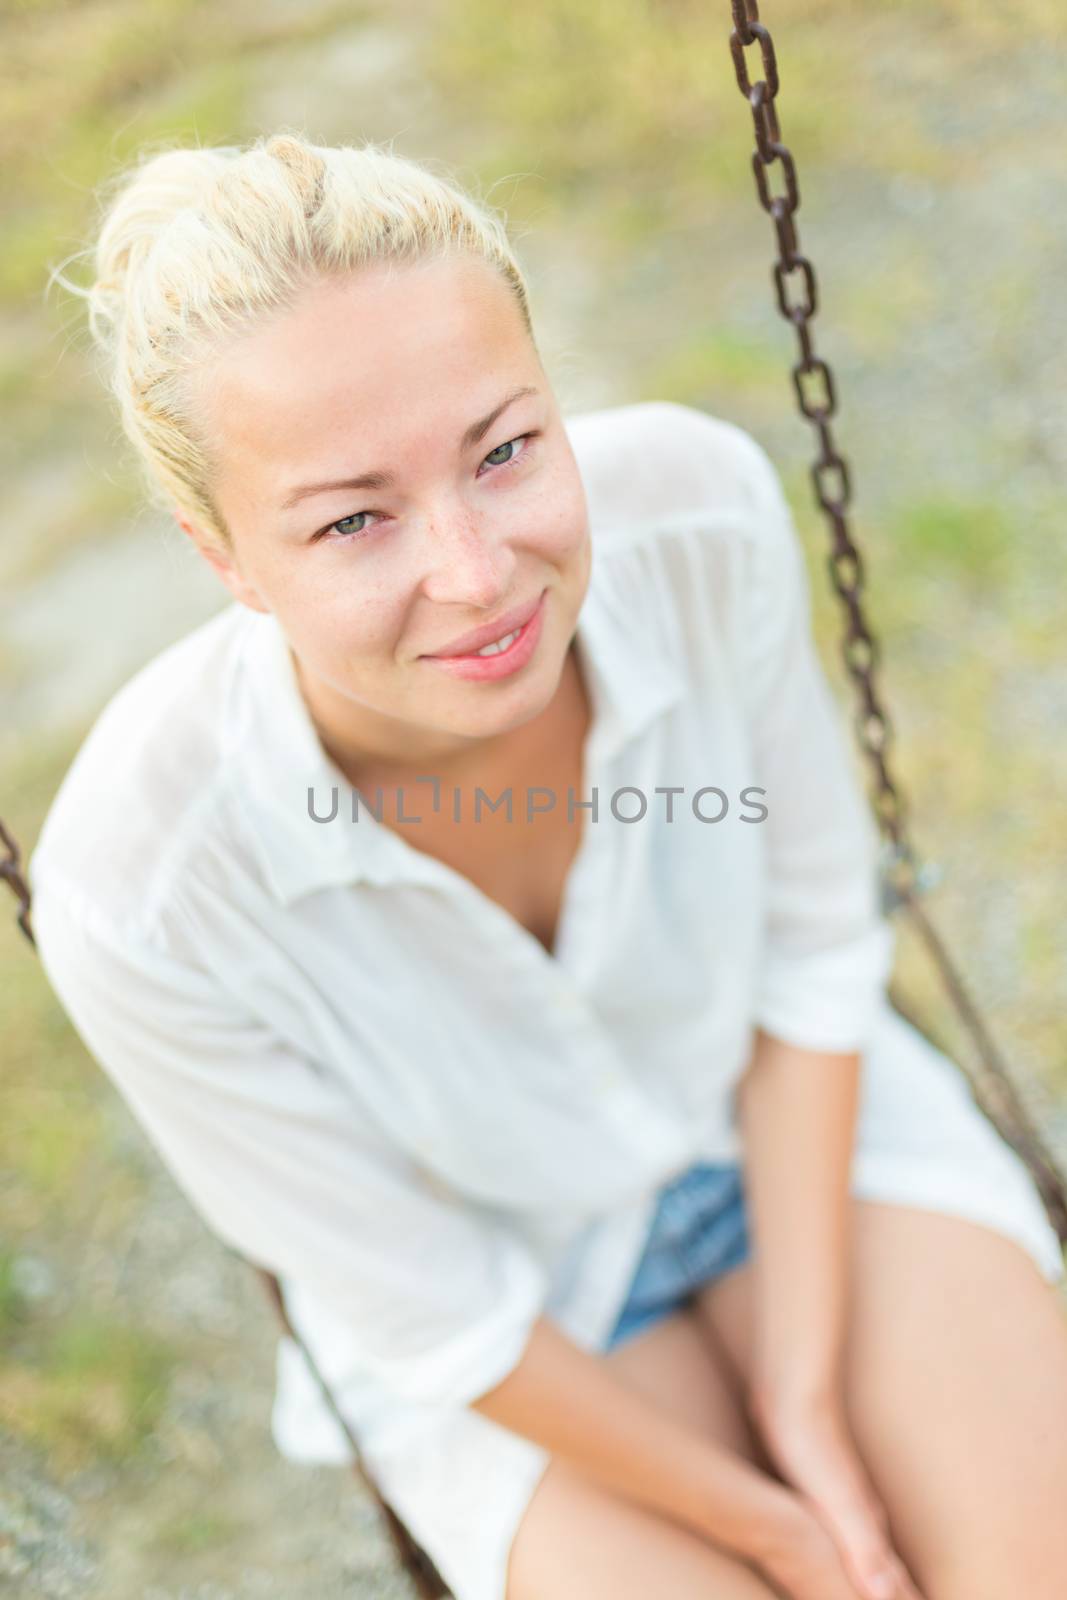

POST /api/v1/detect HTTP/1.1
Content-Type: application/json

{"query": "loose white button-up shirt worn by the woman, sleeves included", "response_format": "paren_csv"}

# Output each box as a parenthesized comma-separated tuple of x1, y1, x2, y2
(27, 402, 1062, 1600)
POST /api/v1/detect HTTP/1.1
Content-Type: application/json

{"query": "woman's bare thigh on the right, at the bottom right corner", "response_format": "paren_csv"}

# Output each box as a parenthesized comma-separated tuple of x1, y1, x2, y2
(696, 1200, 1067, 1600)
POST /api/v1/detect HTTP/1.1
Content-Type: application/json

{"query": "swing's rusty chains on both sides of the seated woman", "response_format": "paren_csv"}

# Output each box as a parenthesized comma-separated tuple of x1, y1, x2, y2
(0, 0, 1067, 1600)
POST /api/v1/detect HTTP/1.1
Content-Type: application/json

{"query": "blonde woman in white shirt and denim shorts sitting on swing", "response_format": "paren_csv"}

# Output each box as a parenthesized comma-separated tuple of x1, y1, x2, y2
(29, 134, 1067, 1600)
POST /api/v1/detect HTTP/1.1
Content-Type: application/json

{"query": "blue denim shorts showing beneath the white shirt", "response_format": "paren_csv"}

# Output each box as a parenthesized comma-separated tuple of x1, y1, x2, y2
(605, 1162, 749, 1350)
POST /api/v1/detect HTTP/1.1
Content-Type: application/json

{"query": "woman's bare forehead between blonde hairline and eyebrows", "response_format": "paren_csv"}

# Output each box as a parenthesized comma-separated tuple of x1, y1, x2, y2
(200, 258, 536, 486)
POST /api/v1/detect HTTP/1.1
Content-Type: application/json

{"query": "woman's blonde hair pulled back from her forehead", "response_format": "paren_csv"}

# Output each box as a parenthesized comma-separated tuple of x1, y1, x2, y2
(50, 131, 536, 546)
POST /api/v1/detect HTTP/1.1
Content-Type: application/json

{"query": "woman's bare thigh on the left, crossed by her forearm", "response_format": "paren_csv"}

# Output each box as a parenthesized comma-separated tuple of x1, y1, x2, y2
(507, 1310, 773, 1600)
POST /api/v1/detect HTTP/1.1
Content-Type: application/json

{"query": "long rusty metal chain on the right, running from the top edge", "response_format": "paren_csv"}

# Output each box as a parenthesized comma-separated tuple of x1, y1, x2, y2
(729, 0, 1067, 1245)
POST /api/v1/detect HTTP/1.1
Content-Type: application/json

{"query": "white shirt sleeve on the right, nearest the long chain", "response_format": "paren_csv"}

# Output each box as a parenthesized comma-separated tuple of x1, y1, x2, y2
(737, 430, 896, 1053)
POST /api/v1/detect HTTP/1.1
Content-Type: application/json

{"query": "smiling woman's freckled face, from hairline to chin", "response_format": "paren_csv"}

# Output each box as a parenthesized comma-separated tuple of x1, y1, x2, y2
(182, 259, 592, 770)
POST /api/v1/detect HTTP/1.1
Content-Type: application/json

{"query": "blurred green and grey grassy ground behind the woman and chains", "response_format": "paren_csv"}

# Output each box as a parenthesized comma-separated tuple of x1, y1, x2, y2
(0, 0, 1067, 1600)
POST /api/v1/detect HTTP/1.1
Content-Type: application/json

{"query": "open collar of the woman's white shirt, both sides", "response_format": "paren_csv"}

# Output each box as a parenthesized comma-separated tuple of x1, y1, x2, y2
(226, 550, 685, 906)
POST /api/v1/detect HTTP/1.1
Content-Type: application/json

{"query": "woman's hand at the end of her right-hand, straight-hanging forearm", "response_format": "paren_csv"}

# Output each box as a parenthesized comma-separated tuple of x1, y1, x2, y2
(749, 1389, 921, 1600)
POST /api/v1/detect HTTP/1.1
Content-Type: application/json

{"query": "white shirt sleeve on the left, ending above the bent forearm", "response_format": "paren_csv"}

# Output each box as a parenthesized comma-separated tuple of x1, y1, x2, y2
(34, 874, 547, 1406)
